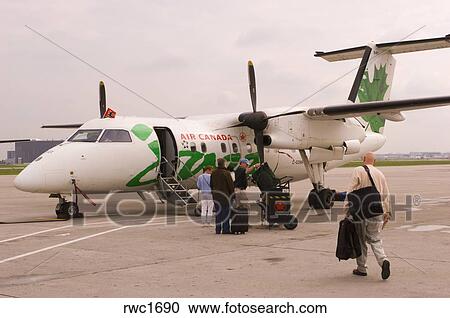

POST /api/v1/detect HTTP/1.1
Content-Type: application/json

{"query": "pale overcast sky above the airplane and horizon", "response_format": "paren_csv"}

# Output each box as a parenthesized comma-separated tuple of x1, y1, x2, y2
(0, 0, 450, 158)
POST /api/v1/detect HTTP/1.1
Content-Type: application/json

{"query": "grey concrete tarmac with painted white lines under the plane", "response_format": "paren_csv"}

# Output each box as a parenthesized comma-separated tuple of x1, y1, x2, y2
(0, 166, 450, 297)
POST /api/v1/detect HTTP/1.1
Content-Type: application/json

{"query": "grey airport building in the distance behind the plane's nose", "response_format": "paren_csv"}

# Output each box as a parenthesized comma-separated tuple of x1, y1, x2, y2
(12, 140, 63, 164)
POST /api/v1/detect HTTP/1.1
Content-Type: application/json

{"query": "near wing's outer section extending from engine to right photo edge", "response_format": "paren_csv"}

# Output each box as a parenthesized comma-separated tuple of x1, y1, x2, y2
(305, 96, 450, 120)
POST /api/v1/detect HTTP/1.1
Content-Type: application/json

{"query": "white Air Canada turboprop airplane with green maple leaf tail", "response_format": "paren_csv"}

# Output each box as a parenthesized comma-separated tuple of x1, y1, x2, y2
(2, 35, 450, 218)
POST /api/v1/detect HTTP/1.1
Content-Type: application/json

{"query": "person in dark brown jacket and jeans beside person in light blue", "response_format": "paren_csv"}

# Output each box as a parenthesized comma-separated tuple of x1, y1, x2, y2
(211, 158, 234, 234)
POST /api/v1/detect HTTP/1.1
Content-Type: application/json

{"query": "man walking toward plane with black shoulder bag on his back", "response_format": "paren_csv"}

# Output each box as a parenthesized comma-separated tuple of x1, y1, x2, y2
(346, 153, 391, 279)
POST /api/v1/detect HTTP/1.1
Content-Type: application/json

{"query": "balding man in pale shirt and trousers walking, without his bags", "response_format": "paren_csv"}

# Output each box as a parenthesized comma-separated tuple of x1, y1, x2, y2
(346, 152, 390, 279)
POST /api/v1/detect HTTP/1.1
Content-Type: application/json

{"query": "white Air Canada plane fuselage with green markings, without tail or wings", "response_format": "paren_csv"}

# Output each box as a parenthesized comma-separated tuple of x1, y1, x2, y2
(15, 110, 385, 194)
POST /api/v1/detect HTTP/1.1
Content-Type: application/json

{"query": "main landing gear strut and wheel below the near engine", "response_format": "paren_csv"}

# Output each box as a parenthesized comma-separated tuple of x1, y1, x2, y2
(299, 149, 336, 209)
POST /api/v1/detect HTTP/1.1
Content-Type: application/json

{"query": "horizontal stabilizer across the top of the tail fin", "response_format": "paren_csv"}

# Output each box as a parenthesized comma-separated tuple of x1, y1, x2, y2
(314, 34, 450, 62)
